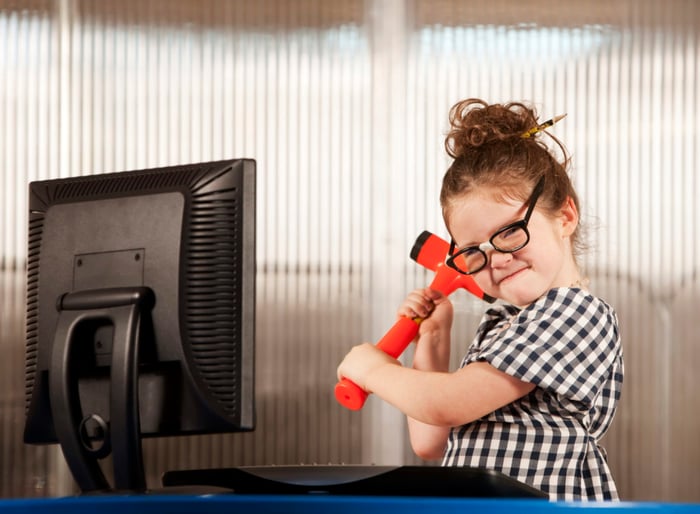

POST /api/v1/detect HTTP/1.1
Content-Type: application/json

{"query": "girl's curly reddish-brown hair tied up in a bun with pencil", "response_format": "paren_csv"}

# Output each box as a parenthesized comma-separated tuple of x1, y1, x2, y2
(440, 98, 580, 253)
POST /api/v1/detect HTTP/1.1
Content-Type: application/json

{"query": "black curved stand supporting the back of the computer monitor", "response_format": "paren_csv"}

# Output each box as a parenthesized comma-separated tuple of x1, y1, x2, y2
(49, 287, 155, 493)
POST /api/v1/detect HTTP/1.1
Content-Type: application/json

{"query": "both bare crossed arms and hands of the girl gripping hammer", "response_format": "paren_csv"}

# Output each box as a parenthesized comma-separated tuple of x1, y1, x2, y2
(338, 289, 535, 460)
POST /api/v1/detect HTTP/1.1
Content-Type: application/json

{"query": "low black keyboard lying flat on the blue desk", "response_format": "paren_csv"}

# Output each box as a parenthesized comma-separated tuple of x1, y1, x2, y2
(162, 465, 548, 498)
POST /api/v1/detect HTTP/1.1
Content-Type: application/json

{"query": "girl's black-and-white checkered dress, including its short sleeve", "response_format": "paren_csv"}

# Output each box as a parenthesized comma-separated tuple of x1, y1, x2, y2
(443, 288, 623, 500)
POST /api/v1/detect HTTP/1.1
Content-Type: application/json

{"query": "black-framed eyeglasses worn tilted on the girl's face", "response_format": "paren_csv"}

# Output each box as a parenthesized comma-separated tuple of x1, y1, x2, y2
(446, 177, 544, 275)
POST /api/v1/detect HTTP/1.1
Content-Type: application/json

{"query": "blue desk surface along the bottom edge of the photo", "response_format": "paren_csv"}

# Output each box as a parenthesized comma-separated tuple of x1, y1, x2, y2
(0, 493, 700, 514)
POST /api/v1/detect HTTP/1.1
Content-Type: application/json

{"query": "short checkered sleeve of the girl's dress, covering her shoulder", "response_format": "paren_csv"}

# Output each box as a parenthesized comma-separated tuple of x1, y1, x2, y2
(472, 288, 619, 405)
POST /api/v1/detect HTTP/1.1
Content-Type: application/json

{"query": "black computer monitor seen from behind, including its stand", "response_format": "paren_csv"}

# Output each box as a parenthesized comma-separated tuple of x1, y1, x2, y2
(24, 159, 255, 492)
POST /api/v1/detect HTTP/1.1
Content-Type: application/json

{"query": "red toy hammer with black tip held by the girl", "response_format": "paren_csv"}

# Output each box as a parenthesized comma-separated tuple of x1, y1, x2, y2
(335, 230, 496, 410)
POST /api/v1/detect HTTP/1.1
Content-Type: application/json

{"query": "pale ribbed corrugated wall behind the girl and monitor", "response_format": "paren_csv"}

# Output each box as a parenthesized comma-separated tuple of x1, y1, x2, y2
(0, 0, 700, 501)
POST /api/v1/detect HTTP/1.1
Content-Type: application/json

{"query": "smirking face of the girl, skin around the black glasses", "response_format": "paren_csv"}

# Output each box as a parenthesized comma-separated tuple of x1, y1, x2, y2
(448, 188, 581, 306)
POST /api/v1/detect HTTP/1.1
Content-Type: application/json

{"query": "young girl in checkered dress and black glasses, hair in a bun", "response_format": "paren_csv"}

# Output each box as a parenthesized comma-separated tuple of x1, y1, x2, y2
(338, 99, 623, 500)
